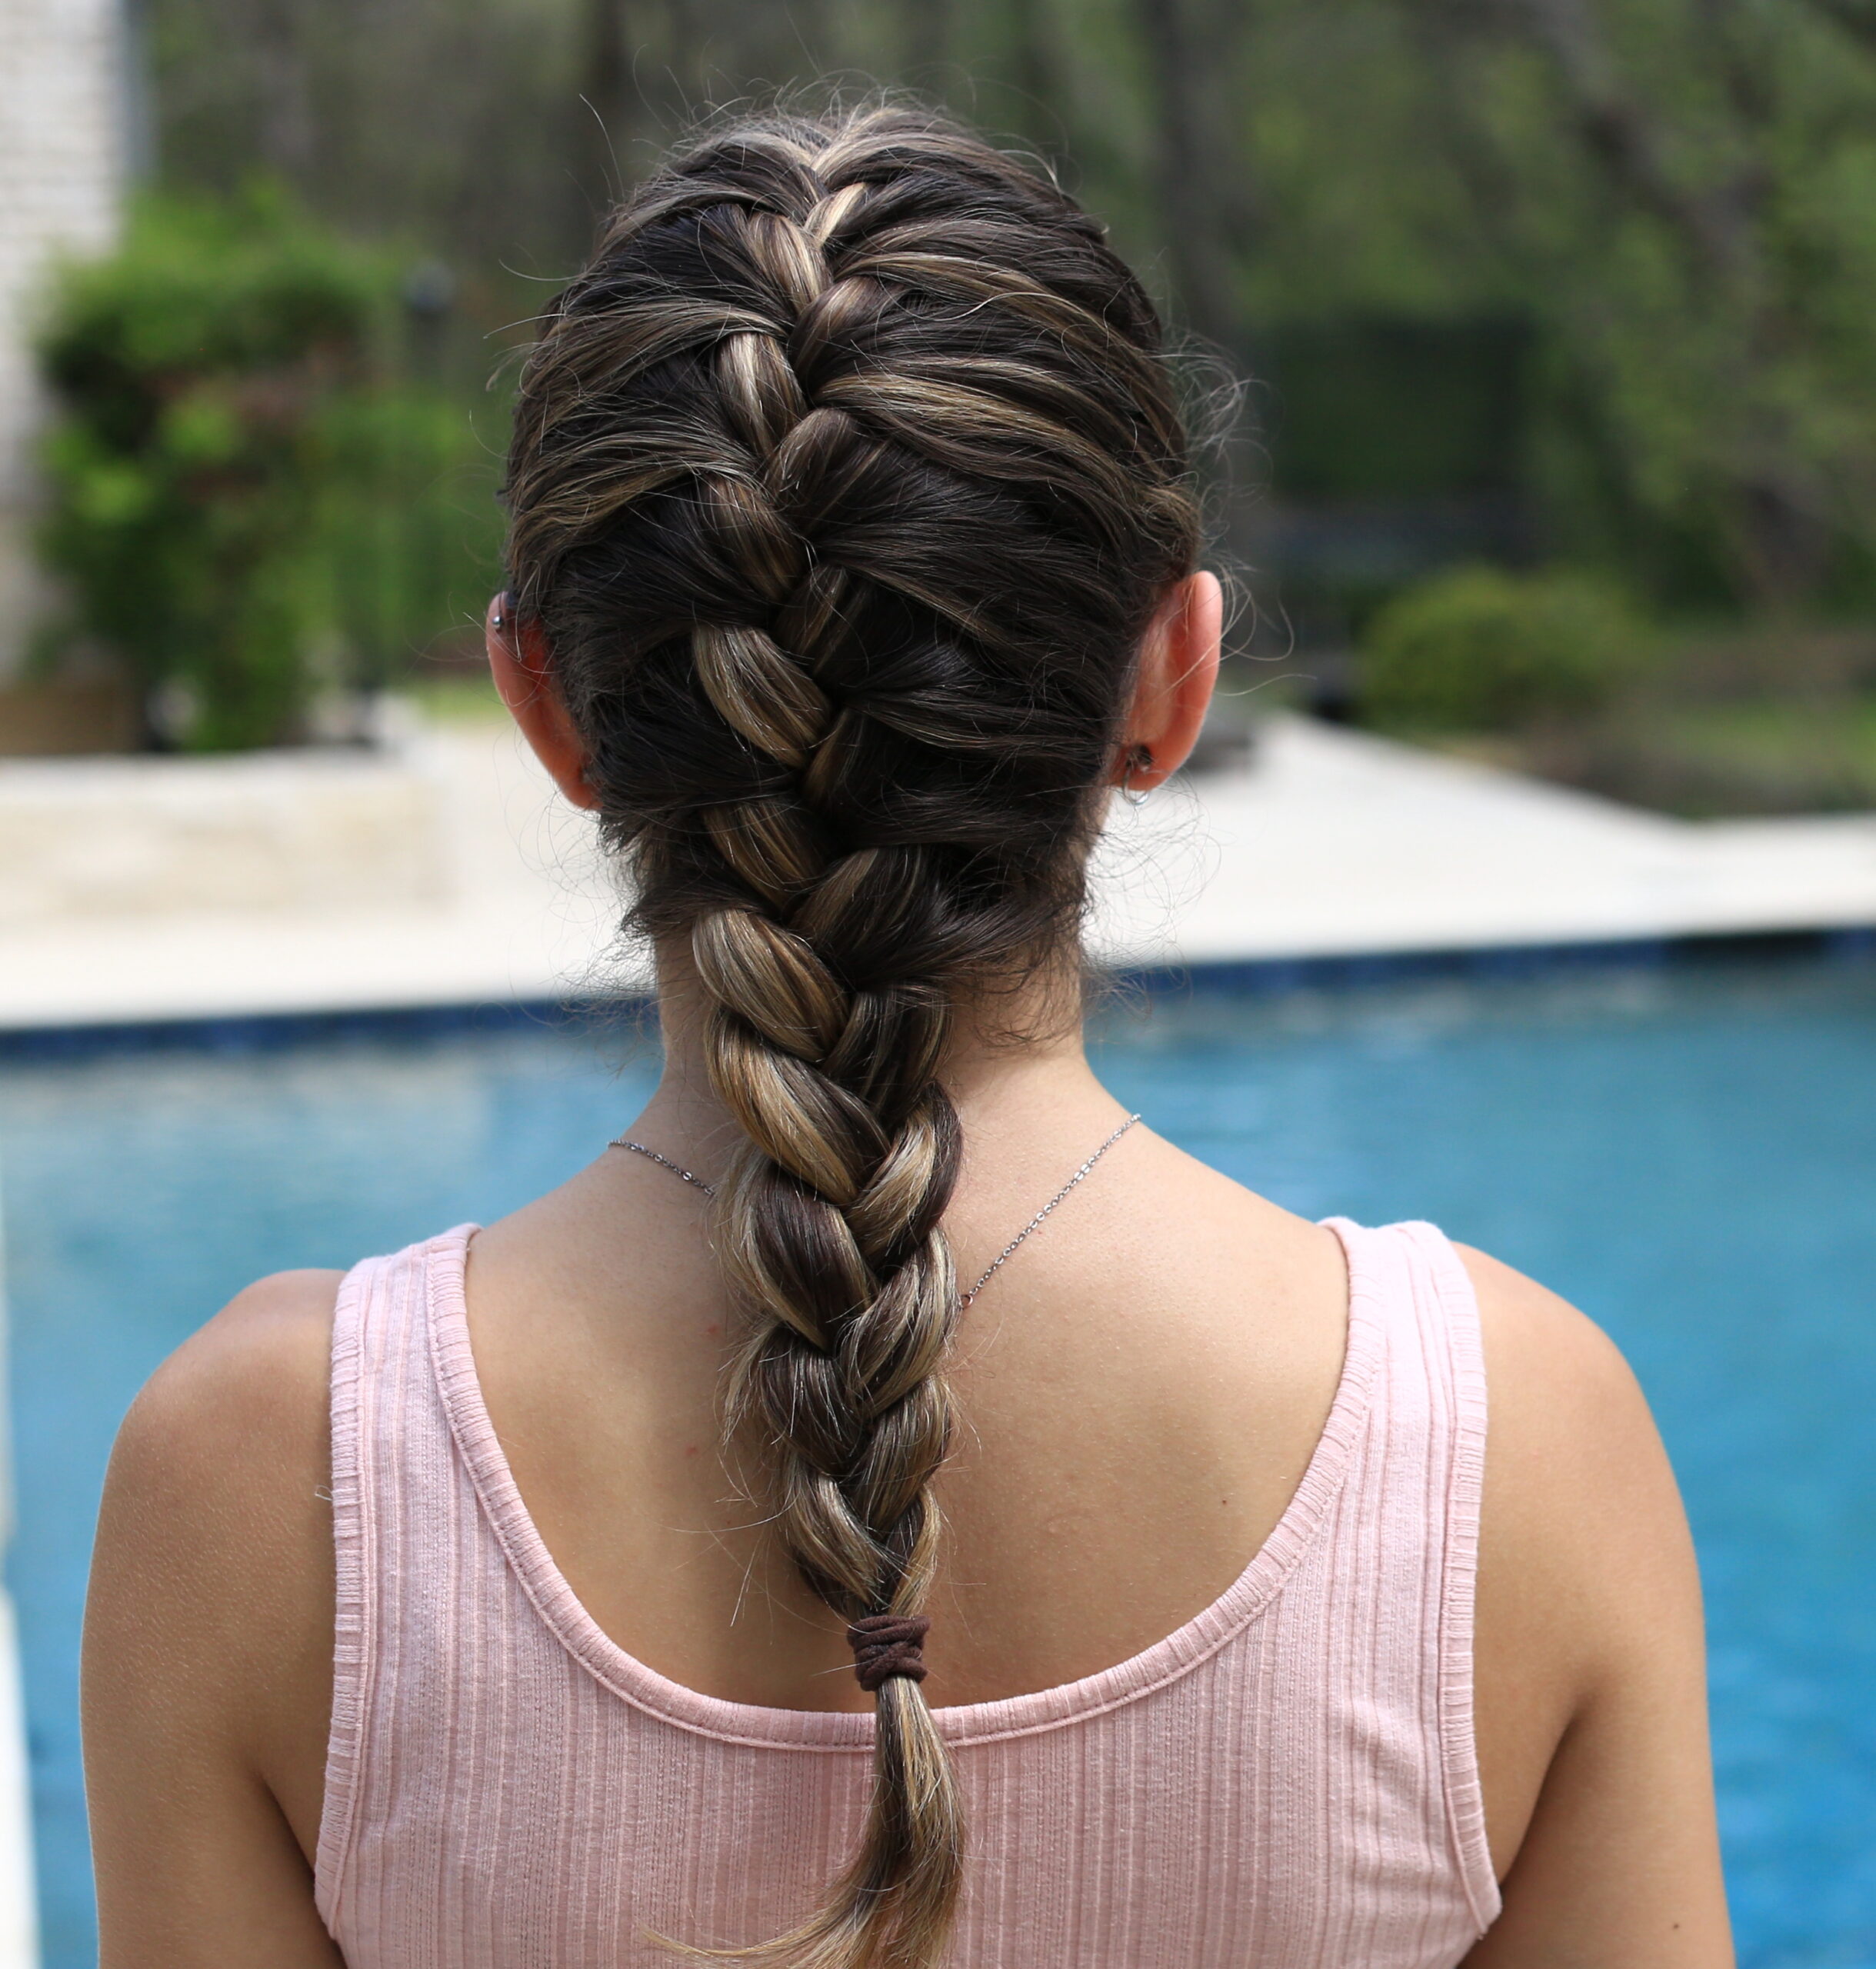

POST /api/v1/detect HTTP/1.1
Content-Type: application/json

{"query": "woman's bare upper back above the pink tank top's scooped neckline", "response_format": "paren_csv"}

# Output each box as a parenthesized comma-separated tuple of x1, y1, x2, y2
(455, 1134, 1347, 1709)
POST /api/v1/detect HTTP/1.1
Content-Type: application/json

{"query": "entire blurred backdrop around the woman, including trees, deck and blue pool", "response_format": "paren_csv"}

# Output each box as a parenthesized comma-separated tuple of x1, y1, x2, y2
(0, 12, 1876, 1969)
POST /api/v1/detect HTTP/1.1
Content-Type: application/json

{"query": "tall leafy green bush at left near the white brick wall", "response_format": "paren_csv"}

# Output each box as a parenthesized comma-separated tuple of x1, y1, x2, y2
(39, 189, 494, 752)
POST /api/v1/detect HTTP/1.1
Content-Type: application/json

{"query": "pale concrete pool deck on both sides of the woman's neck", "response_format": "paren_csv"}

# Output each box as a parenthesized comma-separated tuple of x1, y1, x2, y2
(0, 717, 1876, 1030)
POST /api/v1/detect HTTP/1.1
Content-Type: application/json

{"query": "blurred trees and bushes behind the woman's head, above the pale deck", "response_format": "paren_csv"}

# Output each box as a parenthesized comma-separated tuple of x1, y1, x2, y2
(11, 0, 1876, 813)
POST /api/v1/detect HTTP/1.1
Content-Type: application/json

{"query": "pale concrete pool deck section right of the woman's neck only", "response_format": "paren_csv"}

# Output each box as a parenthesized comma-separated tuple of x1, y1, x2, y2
(1097, 718, 1876, 965)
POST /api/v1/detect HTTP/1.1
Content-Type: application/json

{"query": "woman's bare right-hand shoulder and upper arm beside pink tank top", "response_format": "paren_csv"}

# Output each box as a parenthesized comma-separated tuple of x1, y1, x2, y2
(1461, 1248, 1724, 1937)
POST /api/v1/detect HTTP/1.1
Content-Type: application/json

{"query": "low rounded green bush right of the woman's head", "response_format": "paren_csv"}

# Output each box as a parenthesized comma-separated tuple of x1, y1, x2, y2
(1358, 567, 1650, 732)
